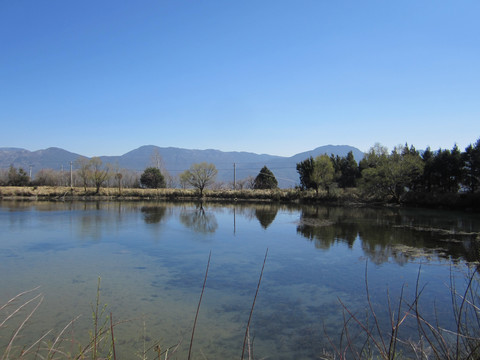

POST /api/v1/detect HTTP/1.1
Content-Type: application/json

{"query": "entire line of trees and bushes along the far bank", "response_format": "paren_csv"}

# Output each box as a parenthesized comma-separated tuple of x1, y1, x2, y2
(0, 138, 480, 202)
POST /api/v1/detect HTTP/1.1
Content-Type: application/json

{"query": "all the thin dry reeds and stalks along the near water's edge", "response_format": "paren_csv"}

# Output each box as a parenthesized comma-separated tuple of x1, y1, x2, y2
(0, 262, 480, 360)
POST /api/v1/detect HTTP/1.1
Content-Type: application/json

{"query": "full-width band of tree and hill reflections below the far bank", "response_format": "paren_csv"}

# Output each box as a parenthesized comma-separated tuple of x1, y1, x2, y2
(2, 201, 480, 264)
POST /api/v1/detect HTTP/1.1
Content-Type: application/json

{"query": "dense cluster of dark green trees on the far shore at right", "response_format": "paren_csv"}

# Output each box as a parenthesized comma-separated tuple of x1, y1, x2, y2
(297, 139, 480, 202)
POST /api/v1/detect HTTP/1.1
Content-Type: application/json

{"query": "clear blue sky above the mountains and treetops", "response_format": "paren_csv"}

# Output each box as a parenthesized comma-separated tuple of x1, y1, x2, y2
(0, 0, 480, 156)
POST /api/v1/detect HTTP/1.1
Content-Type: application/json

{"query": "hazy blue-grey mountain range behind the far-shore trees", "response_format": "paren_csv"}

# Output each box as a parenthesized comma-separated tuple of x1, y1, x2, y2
(0, 145, 364, 188)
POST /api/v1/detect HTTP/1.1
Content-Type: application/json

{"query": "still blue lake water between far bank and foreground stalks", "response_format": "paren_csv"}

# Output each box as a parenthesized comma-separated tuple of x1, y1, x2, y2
(0, 201, 480, 359)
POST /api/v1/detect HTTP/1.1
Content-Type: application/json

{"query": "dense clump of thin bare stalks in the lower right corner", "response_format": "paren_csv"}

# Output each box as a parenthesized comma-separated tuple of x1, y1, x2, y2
(321, 266, 480, 360)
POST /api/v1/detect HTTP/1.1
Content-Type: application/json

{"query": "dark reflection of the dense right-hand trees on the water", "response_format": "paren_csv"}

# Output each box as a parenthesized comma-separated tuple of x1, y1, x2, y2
(297, 206, 480, 264)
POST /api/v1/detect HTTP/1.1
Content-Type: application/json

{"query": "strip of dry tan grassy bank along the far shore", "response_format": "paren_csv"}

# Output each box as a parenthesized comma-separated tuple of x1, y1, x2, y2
(0, 186, 480, 211)
